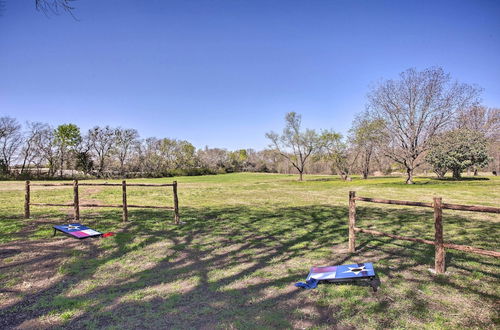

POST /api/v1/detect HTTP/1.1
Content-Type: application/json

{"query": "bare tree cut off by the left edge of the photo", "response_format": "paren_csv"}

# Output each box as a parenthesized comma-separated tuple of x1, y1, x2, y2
(0, 117, 22, 174)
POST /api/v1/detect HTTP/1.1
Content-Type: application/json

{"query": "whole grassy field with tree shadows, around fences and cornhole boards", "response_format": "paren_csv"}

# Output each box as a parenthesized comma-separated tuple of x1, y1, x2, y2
(0, 173, 500, 329)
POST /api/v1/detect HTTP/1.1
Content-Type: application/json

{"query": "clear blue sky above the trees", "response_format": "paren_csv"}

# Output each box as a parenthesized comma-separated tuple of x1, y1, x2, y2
(0, 0, 500, 149)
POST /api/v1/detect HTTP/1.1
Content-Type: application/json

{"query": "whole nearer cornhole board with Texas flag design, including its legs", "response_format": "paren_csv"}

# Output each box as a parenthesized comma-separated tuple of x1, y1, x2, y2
(306, 262, 378, 291)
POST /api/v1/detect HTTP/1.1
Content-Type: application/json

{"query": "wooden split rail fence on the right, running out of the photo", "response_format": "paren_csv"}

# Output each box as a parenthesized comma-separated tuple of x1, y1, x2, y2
(349, 191, 500, 274)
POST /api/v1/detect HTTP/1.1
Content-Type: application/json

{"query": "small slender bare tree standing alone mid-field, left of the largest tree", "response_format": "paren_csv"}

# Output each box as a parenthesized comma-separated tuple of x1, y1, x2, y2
(266, 112, 320, 181)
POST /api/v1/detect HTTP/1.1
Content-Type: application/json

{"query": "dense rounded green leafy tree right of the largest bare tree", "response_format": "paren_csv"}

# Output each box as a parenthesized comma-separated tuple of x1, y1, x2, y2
(426, 129, 489, 179)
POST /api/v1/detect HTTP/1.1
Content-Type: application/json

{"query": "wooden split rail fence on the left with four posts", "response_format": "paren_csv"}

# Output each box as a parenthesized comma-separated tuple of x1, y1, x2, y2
(24, 180, 180, 224)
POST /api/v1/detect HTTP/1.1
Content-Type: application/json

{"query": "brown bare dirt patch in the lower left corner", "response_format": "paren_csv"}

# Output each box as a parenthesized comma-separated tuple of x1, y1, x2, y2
(0, 238, 99, 329)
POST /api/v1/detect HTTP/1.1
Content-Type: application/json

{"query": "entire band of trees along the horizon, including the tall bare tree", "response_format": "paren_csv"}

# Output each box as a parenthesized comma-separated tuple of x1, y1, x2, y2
(0, 68, 500, 183)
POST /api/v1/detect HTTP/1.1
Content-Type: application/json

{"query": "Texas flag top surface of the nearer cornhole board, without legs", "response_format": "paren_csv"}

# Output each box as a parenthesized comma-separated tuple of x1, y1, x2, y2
(307, 262, 375, 281)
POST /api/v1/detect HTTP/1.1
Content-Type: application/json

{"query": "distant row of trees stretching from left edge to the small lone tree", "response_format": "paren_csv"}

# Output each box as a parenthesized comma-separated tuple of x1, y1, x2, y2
(0, 117, 292, 178)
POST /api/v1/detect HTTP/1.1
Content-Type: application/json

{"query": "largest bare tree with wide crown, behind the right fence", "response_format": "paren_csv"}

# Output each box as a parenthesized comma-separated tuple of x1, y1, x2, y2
(368, 68, 480, 184)
